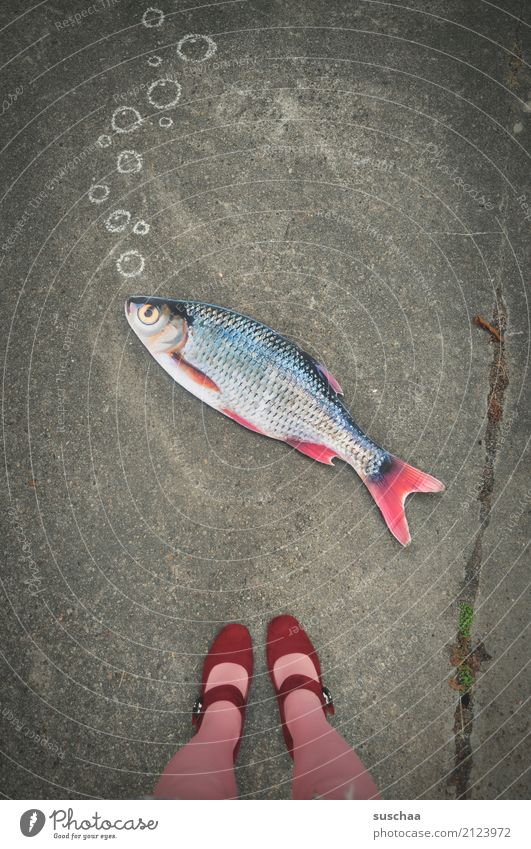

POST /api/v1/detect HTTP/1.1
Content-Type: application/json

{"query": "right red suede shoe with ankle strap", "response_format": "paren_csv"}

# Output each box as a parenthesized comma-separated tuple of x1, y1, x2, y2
(267, 616, 334, 757)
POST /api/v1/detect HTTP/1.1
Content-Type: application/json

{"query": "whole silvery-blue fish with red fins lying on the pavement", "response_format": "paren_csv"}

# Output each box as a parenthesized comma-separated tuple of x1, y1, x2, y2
(125, 295, 444, 545)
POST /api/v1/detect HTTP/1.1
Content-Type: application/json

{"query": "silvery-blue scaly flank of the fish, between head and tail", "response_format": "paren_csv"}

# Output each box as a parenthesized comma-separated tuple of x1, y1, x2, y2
(166, 301, 388, 475)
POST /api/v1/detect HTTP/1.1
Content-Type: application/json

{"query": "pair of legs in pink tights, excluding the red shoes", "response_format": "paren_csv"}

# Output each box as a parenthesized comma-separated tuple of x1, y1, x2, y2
(155, 617, 379, 799)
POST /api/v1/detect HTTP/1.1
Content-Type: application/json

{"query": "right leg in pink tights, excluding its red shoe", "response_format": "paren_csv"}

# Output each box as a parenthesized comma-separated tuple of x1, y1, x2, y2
(274, 654, 380, 799)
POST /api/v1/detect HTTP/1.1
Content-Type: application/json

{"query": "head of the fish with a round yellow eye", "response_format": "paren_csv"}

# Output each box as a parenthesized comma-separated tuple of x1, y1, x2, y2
(125, 295, 188, 355)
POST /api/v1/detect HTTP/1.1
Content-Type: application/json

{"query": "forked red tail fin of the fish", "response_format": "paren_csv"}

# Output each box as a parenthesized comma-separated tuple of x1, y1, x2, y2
(363, 455, 444, 545)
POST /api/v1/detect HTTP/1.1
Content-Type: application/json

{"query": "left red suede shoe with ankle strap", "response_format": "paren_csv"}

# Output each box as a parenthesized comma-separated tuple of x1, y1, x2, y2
(192, 623, 253, 760)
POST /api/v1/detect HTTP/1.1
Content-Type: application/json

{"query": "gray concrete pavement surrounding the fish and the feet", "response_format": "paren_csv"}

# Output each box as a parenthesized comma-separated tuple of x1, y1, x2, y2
(0, 0, 531, 799)
